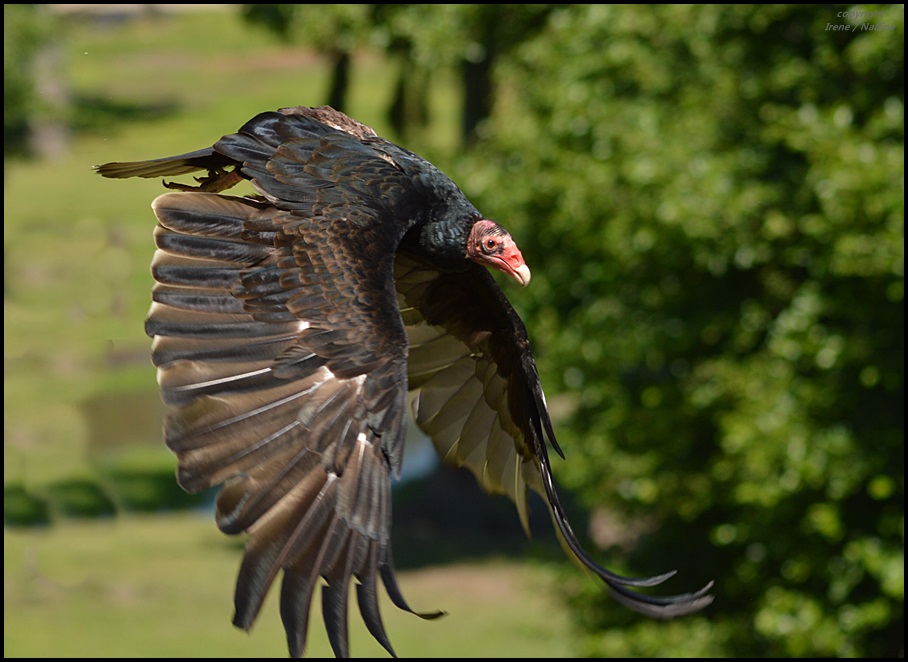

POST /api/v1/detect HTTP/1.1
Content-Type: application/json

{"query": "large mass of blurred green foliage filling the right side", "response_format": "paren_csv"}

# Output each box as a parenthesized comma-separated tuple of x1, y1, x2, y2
(458, 5, 904, 657)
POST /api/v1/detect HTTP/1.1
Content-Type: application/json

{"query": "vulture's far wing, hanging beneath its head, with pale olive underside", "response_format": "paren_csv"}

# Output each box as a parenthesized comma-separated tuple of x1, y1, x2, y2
(395, 254, 712, 618)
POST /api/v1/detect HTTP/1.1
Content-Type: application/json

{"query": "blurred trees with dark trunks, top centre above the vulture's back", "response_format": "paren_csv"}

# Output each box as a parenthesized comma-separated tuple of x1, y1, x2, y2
(242, 4, 560, 144)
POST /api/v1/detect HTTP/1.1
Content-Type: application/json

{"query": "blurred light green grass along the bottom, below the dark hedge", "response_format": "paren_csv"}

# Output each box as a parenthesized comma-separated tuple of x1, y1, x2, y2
(3, 513, 569, 658)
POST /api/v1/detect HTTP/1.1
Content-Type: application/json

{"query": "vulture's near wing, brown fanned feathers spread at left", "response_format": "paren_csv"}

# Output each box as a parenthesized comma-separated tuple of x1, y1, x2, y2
(147, 193, 440, 656)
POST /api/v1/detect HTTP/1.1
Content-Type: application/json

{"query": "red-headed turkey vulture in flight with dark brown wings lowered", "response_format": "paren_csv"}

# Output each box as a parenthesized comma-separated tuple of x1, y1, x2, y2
(97, 106, 712, 657)
